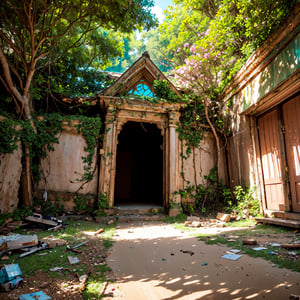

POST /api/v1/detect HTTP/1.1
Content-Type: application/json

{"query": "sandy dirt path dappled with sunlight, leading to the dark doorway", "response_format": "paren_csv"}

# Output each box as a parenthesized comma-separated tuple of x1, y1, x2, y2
(108, 222, 300, 300)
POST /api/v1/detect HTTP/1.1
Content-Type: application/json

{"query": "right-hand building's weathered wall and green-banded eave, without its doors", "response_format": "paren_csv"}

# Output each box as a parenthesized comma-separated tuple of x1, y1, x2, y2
(224, 10, 300, 205)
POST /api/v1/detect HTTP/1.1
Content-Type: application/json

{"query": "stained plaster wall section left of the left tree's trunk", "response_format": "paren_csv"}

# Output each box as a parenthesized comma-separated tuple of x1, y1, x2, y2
(0, 144, 22, 213)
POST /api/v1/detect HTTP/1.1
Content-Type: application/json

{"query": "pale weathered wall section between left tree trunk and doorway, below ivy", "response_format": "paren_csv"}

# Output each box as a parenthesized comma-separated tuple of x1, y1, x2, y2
(37, 131, 98, 209)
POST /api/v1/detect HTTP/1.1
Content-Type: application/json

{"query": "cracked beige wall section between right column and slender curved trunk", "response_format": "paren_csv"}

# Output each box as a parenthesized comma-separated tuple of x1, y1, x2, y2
(181, 133, 217, 202)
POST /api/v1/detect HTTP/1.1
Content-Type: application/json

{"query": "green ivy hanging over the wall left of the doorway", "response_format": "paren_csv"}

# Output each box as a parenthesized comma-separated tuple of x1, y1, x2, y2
(0, 113, 102, 183)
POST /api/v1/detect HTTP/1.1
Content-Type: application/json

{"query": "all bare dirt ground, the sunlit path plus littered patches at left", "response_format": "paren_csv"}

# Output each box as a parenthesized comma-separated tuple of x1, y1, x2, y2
(0, 221, 300, 300)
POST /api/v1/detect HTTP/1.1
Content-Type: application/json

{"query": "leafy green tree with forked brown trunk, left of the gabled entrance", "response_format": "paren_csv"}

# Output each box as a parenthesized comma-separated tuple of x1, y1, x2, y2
(0, 0, 155, 204)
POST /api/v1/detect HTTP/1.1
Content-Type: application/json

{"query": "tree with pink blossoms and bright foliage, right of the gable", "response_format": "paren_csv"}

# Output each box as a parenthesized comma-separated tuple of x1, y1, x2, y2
(164, 0, 297, 179)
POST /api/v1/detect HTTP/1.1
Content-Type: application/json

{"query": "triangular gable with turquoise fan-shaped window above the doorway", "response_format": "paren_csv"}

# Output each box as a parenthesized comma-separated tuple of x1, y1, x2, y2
(103, 52, 181, 97)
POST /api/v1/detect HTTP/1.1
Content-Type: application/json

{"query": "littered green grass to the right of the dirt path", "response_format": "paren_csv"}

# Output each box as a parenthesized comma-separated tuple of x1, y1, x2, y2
(197, 225, 300, 272)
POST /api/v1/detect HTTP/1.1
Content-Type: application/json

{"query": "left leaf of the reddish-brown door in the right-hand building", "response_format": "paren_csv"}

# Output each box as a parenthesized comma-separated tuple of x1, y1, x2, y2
(258, 109, 284, 210)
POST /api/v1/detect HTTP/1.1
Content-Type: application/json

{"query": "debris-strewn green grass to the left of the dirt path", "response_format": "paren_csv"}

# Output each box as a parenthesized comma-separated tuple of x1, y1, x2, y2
(5, 220, 116, 299)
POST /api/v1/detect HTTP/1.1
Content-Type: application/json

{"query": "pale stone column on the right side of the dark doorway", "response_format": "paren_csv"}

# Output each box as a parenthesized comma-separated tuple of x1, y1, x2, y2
(168, 111, 181, 216)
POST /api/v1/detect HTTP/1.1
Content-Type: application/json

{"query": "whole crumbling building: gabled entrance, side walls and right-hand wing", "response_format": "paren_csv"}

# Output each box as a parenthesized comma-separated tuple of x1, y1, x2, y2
(0, 10, 300, 223)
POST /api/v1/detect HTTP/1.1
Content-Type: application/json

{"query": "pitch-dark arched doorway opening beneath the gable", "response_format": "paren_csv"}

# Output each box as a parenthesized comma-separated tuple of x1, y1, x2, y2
(114, 122, 163, 206)
